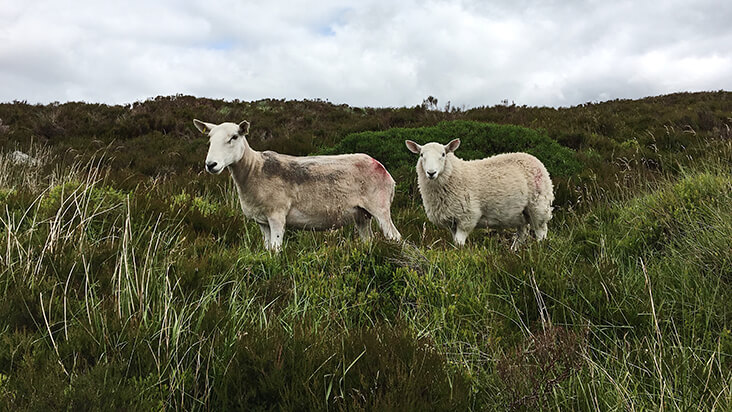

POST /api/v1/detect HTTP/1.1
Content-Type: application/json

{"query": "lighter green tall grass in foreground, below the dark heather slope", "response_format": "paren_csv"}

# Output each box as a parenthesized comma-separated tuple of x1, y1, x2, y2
(0, 128, 732, 411)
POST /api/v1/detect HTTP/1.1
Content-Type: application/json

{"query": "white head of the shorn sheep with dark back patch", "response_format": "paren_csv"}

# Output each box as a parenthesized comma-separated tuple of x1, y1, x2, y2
(193, 119, 249, 174)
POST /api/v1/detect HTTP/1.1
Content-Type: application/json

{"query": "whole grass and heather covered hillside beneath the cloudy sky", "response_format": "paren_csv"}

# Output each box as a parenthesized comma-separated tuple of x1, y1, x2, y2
(0, 91, 732, 410)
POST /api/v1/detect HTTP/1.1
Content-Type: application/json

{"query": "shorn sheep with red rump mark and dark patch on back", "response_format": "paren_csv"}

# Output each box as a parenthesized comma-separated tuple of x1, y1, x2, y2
(193, 119, 401, 252)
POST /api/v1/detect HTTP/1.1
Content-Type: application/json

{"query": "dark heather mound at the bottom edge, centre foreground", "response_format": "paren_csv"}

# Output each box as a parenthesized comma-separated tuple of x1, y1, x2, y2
(213, 325, 469, 411)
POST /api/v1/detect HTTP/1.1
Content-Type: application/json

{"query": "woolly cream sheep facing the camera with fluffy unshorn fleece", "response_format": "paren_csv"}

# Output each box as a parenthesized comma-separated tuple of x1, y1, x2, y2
(405, 139, 554, 250)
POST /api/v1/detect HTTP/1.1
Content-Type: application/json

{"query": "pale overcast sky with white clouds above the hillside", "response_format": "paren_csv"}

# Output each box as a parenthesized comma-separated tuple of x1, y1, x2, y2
(0, 0, 732, 108)
